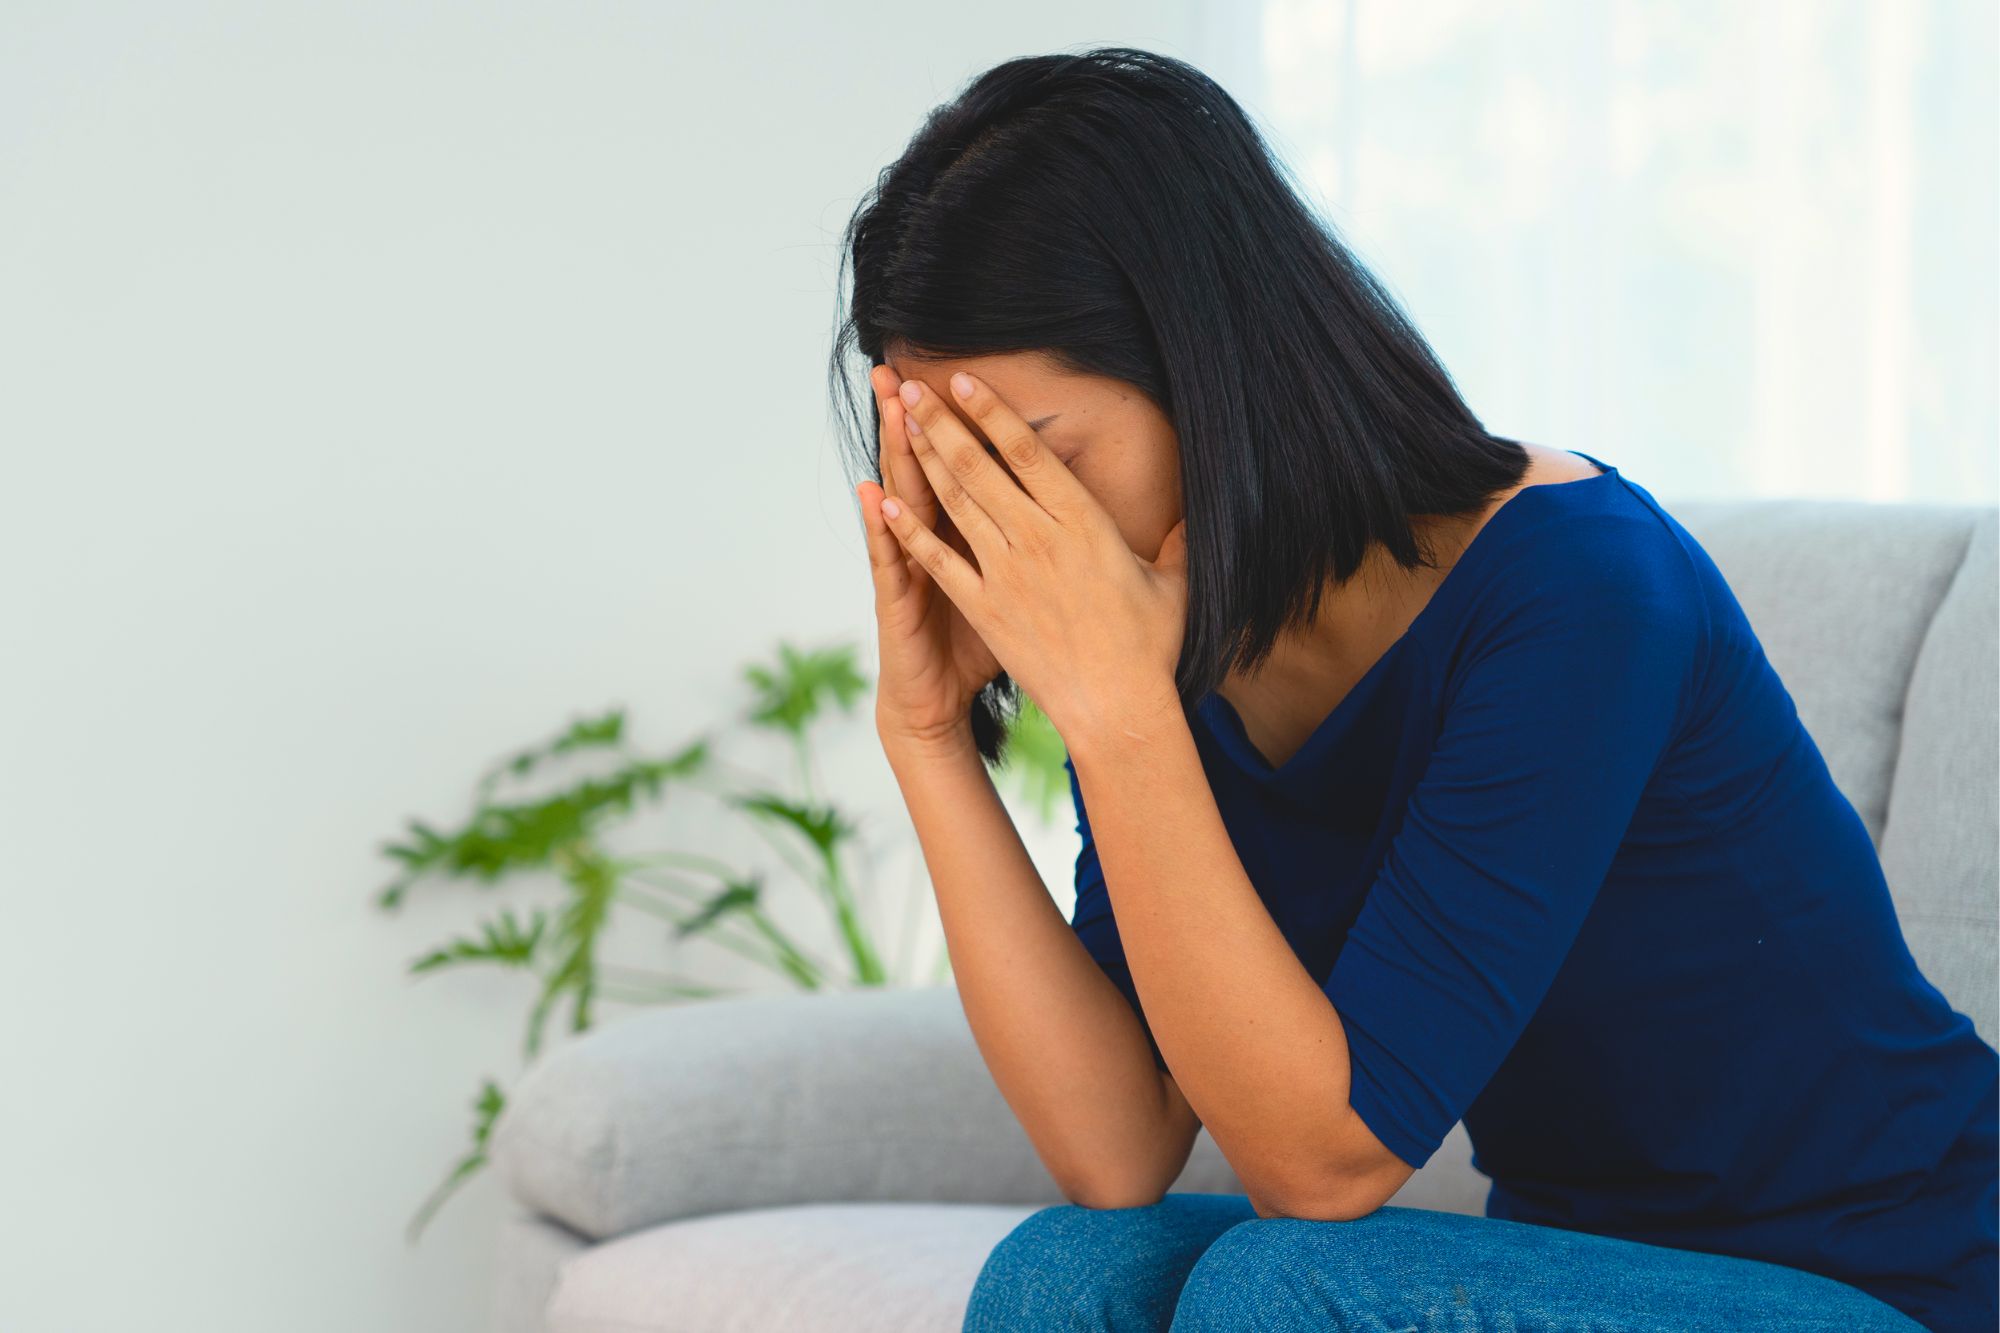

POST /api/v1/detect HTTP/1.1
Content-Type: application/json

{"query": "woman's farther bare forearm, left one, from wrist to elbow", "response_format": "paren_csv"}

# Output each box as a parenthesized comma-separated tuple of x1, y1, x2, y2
(884, 737, 1192, 1207)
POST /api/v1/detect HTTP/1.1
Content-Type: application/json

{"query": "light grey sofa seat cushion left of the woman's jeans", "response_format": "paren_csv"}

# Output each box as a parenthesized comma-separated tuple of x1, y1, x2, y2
(546, 1203, 1038, 1333)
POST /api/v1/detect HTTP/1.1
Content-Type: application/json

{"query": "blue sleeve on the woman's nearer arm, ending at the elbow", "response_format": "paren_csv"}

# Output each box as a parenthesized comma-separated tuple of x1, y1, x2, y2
(1322, 546, 1702, 1167)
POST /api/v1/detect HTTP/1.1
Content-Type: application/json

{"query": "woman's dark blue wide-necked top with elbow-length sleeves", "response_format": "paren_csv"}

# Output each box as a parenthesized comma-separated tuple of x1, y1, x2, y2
(1070, 450, 2000, 1333)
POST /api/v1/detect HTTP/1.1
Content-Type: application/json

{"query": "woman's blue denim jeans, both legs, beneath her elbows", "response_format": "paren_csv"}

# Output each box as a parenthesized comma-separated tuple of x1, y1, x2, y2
(964, 1193, 1924, 1333)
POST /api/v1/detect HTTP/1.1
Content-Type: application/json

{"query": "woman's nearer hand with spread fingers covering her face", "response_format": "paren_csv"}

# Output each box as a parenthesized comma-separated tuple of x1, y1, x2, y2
(882, 372, 1188, 749)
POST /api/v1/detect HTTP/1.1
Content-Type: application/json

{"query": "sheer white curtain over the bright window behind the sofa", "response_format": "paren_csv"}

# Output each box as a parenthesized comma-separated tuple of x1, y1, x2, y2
(1200, 0, 2000, 502)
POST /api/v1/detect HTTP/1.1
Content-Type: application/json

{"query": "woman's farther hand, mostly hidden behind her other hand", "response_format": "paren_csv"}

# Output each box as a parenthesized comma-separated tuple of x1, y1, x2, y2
(856, 366, 1000, 745)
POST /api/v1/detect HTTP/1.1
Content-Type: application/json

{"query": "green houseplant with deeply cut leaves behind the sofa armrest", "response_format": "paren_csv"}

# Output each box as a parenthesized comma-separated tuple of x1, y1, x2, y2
(376, 642, 1068, 1241)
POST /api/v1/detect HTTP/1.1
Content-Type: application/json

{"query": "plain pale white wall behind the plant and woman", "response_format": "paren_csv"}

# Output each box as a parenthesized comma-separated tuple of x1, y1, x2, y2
(0, 0, 1216, 1333)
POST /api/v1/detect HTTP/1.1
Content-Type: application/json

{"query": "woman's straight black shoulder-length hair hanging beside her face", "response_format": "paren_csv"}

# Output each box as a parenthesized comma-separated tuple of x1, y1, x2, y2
(828, 46, 1528, 763)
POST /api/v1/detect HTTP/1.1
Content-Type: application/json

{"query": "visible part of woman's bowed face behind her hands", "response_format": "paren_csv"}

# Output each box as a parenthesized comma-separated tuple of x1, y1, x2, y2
(888, 350, 1180, 560)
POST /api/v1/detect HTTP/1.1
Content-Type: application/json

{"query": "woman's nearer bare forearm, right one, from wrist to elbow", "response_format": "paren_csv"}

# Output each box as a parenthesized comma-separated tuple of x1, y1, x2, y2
(1070, 689, 1366, 1213)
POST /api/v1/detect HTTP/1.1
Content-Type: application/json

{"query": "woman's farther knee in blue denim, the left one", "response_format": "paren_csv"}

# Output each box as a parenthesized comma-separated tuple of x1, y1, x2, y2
(964, 1195, 1256, 1333)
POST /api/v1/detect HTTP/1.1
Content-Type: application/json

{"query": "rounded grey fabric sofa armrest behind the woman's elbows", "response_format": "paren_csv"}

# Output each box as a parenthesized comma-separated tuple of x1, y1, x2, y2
(492, 985, 1242, 1239)
